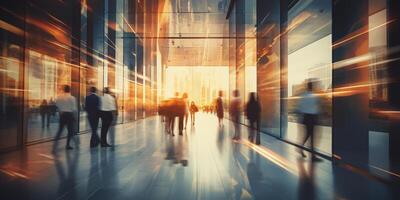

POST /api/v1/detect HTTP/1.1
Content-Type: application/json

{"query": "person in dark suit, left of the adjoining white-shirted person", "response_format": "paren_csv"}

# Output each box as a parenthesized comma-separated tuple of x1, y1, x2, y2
(85, 87, 100, 147)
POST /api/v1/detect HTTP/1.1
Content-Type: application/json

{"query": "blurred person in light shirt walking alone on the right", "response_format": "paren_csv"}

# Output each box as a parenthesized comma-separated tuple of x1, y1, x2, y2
(298, 81, 319, 160)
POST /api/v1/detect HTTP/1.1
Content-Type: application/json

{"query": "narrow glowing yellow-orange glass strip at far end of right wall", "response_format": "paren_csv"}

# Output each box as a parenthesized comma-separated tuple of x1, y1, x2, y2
(229, 0, 257, 124)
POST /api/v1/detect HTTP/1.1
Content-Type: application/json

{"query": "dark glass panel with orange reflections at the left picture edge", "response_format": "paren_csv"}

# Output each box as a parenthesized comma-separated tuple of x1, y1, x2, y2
(0, 1, 24, 149)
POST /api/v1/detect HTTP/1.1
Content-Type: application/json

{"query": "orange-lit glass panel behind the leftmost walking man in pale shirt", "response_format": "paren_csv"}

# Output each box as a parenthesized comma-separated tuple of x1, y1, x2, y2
(25, 1, 79, 142)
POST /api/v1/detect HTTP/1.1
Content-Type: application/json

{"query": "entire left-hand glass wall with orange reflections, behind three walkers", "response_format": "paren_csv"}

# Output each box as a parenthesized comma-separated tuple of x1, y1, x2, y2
(0, 0, 159, 150)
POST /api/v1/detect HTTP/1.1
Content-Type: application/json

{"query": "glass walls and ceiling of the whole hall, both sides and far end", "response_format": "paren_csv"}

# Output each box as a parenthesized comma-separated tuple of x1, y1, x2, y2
(0, 0, 400, 180)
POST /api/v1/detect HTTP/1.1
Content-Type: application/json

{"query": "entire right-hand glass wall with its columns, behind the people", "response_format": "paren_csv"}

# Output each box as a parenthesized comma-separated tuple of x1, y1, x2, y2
(228, 0, 400, 177)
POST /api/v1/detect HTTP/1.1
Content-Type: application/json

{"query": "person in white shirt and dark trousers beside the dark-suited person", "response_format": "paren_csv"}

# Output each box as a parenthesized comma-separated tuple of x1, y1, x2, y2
(100, 87, 117, 147)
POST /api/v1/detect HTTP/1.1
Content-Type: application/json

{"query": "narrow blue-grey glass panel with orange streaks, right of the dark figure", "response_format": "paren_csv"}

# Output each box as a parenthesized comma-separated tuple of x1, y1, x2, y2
(257, 0, 281, 136)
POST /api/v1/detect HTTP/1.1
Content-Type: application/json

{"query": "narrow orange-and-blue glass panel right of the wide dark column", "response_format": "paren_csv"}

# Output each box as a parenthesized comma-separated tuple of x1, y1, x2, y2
(368, 7, 395, 173)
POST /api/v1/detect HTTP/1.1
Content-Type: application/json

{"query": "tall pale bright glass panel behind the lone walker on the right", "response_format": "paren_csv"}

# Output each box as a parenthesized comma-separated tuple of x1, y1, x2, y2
(283, 0, 332, 155)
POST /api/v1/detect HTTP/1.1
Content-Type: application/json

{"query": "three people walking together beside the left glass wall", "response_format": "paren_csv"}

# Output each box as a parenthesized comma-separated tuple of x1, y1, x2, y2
(53, 85, 118, 151)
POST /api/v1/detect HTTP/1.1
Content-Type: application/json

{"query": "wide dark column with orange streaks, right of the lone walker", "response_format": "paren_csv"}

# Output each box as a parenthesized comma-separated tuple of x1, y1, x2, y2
(332, 0, 369, 166)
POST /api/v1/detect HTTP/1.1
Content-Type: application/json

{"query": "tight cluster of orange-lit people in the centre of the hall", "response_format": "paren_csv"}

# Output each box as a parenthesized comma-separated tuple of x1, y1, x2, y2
(158, 92, 199, 136)
